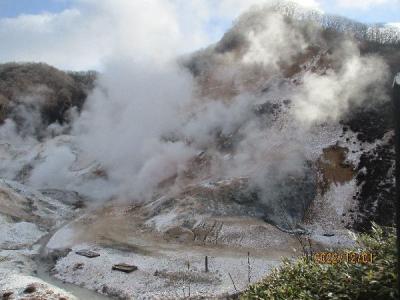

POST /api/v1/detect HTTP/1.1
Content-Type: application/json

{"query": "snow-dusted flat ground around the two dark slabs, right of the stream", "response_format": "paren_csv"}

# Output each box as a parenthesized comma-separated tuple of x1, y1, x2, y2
(55, 244, 280, 299)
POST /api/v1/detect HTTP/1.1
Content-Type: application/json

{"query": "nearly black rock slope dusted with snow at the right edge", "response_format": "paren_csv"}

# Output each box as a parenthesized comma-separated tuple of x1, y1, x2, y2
(343, 101, 395, 231)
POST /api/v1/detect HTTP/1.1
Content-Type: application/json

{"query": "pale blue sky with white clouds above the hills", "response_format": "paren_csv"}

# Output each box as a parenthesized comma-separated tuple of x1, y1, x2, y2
(0, 0, 400, 70)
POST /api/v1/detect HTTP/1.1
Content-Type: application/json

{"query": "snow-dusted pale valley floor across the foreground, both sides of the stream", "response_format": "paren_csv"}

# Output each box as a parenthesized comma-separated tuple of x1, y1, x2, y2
(0, 177, 296, 300)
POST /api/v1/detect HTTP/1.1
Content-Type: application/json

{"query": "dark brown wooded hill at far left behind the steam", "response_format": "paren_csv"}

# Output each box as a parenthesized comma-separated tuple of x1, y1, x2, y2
(0, 63, 96, 137)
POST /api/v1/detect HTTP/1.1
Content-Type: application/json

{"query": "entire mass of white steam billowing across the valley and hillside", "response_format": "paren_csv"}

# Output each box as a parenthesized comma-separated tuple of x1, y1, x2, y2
(0, 1, 388, 209)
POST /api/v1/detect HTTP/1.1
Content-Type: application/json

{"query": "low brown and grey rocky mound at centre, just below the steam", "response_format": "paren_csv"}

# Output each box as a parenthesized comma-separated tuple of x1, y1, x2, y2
(145, 171, 317, 231)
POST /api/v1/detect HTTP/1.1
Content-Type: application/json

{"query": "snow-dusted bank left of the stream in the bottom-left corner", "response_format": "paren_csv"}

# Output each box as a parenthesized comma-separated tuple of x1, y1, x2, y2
(0, 180, 81, 300)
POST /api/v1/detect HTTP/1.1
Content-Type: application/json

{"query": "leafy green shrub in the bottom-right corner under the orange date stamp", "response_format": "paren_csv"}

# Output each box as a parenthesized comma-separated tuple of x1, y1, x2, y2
(241, 225, 398, 300)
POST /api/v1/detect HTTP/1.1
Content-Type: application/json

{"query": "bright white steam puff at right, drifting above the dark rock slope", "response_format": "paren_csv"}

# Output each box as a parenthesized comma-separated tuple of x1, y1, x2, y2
(293, 43, 389, 124)
